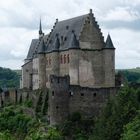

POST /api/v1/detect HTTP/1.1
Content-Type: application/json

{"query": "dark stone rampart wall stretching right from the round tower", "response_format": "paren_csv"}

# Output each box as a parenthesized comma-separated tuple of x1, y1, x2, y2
(69, 85, 118, 118)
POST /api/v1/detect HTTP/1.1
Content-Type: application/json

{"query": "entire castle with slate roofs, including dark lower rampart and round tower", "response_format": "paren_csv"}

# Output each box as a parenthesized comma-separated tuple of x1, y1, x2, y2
(21, 10, 116, 124)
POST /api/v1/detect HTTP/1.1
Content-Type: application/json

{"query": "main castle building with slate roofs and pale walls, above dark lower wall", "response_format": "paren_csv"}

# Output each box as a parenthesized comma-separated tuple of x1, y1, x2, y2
(22, 11, 115, 90)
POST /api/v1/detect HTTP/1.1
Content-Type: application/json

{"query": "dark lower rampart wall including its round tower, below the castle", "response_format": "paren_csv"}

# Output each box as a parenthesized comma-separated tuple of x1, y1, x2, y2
(49, 76, 118, 124)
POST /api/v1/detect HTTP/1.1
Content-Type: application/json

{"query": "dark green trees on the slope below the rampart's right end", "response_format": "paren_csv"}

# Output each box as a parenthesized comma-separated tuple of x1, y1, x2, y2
(90, 87, 140, 140)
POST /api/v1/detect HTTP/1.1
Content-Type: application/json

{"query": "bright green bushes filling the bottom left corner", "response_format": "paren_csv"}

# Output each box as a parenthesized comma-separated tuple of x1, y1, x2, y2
(0, 104, 46, 140)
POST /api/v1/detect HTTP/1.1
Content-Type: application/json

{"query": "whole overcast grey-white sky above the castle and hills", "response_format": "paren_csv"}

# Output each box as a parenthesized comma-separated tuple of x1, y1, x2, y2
(0, 0, 140, 69)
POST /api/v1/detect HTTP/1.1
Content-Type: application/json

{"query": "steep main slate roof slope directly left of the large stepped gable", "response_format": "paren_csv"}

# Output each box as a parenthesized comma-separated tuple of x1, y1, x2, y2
(46, 15, 88, 52)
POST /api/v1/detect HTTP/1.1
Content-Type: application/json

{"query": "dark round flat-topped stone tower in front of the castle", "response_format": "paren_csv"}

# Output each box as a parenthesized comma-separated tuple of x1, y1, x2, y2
(49, 75, 70, 125)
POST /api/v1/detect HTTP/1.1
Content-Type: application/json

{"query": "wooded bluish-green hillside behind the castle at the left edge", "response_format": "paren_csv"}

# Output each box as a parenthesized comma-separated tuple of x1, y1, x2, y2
(0, 67, 20, 88)
